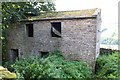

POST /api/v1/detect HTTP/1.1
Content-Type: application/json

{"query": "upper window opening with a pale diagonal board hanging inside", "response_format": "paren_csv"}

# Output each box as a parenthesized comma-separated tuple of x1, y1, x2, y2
(51, 22, 61, 37)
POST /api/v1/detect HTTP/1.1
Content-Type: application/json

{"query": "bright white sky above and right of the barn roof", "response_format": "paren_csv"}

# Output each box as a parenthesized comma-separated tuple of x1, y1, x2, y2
(55, 0, 120, 36)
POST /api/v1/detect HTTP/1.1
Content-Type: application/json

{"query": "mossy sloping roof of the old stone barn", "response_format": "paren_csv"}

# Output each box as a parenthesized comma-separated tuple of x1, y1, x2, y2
(21, 8, 100, 21)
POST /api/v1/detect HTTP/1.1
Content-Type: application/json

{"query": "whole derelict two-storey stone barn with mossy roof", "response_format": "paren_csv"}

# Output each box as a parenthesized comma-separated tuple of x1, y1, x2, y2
(8, 8, 101, 66)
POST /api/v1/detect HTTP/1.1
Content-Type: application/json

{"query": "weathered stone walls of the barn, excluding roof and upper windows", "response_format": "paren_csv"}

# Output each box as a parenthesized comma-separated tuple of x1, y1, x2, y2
(8, 8, 101, 67)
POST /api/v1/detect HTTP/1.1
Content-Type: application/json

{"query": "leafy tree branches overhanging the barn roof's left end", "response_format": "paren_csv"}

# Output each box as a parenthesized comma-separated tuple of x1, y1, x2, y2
(2, 1, 55, 26)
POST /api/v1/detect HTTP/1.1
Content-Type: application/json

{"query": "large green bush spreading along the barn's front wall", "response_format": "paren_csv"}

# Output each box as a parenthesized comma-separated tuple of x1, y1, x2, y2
(6, 51, 92, 79)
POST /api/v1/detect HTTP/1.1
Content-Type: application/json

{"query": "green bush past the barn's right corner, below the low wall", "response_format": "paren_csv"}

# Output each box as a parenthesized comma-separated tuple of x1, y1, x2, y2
(96, 52, 119, 78)
